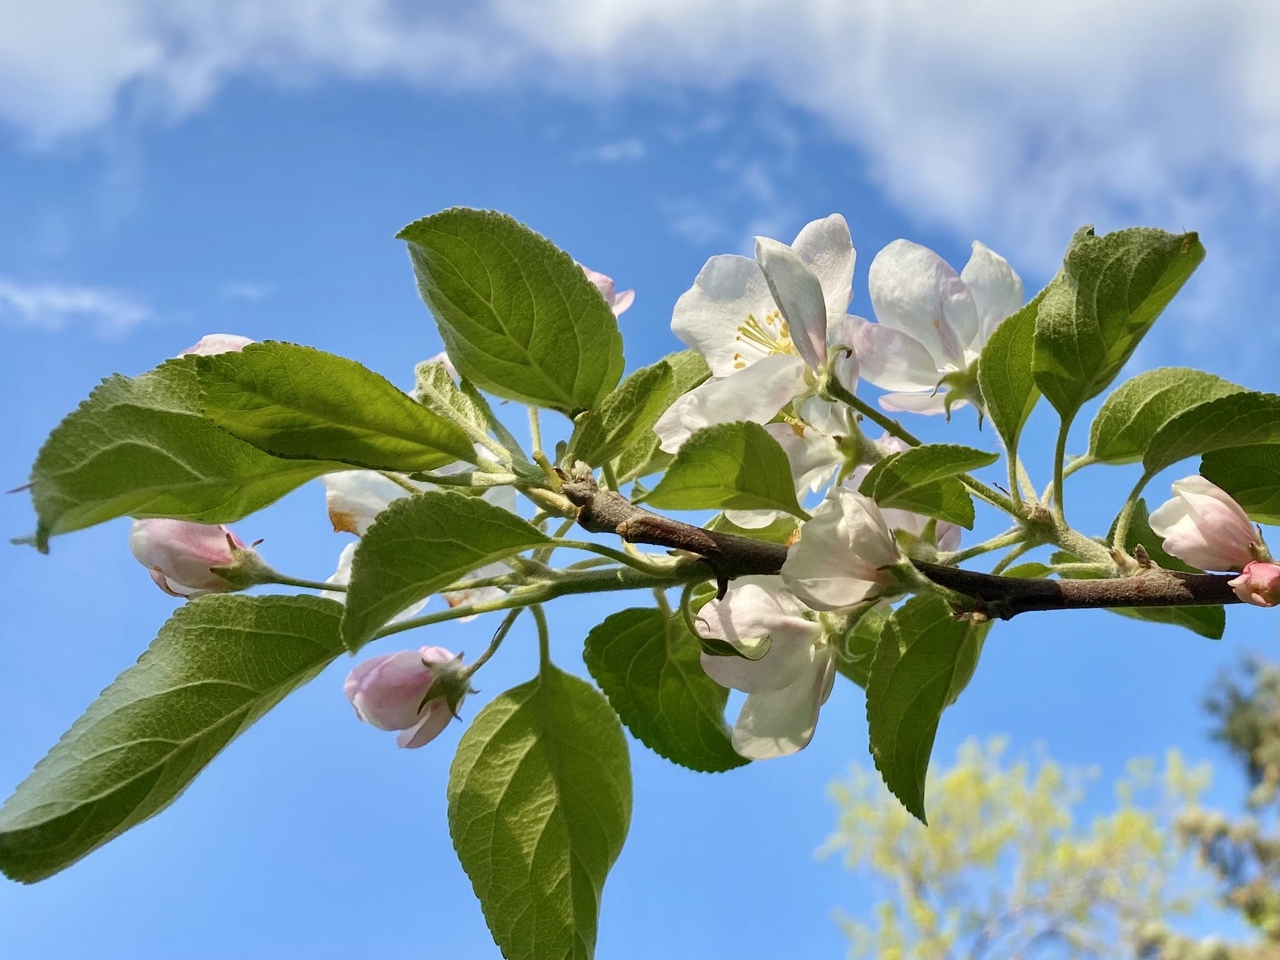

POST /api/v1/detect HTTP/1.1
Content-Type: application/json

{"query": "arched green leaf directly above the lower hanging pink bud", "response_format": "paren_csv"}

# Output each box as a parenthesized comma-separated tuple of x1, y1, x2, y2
(342, 492, 548, 652)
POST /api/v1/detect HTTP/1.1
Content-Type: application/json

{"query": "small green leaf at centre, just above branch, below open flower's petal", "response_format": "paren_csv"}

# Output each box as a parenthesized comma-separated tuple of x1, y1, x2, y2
(646, 421, 804, 516)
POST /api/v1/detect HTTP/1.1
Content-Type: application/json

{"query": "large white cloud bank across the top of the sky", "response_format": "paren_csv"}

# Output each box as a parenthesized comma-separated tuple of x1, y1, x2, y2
(0, 0, 1280, 261)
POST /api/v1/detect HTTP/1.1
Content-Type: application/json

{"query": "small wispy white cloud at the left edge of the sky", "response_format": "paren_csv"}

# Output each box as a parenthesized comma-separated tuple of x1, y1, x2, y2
(0, 279, 152, 338)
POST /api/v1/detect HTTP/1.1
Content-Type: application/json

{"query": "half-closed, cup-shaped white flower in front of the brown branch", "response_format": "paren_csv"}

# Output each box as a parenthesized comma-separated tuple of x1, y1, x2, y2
(782, 486, 901, 611)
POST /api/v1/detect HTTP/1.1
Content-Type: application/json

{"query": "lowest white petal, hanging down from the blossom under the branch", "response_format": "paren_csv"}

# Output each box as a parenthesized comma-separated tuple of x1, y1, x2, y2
(733, 646, 835, 760)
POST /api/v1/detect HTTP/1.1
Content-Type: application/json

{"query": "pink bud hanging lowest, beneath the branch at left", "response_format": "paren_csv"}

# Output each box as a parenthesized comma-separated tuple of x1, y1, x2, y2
(342, 646, 461, 748)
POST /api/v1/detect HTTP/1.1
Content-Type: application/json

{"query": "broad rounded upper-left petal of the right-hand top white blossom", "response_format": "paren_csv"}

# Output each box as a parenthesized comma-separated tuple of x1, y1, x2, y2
(863, 239, 980, 379)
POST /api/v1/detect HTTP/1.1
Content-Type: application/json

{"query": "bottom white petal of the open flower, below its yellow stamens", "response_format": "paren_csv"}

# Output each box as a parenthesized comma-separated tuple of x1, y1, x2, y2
(653, 353, 805, 453)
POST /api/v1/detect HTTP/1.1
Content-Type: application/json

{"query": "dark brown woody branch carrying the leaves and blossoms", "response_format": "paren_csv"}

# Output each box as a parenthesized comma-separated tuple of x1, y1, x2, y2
(563, 477, 1240, 620)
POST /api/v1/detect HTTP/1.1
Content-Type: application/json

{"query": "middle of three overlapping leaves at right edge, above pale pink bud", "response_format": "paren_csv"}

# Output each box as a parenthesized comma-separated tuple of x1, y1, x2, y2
(1142, 390, 1280, 477)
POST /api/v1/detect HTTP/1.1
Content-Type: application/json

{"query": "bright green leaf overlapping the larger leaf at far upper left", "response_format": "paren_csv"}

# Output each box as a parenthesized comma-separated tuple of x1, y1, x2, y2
(197, 342, 475, 472)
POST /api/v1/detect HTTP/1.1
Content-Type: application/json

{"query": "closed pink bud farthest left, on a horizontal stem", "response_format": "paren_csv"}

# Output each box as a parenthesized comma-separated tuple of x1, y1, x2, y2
(129, 520, 247, 598)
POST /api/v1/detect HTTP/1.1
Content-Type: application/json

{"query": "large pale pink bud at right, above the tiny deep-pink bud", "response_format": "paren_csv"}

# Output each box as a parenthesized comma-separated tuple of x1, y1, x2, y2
(1149, 476, 1261, 570)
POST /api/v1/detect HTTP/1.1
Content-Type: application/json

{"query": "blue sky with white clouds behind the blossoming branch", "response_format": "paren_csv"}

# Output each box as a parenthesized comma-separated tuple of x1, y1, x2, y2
(0, 0, 1280, 960)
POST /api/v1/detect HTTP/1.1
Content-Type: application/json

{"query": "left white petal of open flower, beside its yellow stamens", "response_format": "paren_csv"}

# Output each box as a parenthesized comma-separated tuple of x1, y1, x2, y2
(671, 255, 776, 376)
